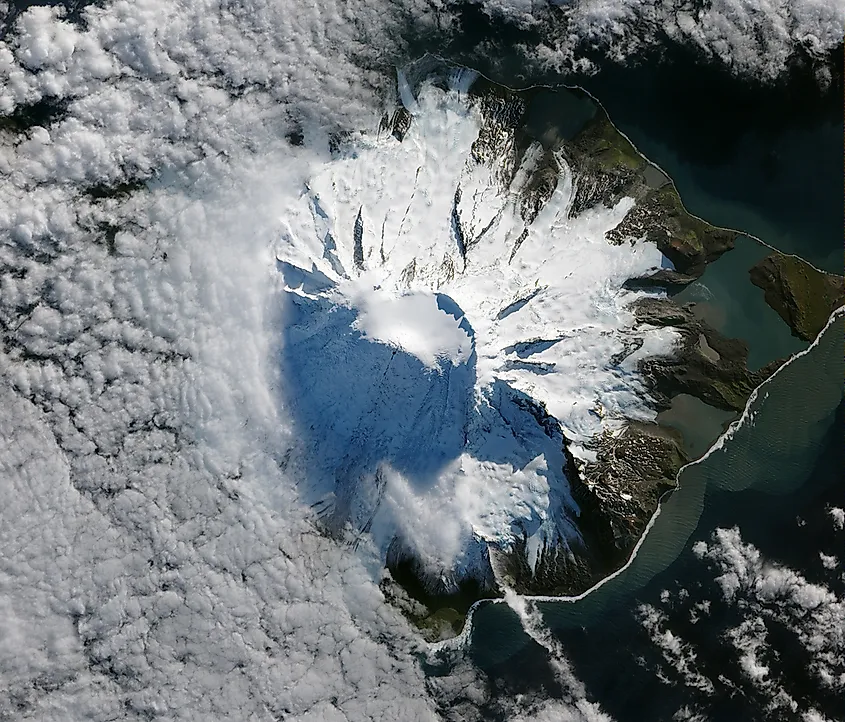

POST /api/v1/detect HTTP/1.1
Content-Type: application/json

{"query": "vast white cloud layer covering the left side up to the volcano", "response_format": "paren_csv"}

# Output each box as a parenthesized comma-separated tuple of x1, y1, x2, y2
(0, 0, 842, 722)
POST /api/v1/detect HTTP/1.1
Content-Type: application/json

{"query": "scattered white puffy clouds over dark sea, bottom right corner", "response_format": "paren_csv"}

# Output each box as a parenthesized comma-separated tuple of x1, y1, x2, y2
(640, 528, 845, 720)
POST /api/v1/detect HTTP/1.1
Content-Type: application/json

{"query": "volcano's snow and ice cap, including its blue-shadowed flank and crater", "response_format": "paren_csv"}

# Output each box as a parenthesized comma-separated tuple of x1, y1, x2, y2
(277, 67, 674, 589)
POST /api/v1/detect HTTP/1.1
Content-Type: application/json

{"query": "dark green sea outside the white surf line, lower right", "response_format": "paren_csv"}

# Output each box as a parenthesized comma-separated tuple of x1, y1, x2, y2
(464, 318, 845, 722)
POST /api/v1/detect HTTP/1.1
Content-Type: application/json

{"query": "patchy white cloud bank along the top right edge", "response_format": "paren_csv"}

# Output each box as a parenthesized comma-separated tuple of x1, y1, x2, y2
(483, 0, 845, 81)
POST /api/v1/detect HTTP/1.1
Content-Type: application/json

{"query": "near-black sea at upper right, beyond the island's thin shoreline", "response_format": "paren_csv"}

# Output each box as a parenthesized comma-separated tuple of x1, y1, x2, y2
(572, 55, 845, 273)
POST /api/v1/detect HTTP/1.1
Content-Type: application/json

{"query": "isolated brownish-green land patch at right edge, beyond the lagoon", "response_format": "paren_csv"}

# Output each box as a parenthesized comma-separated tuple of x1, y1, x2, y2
(749, 253, 845, 341)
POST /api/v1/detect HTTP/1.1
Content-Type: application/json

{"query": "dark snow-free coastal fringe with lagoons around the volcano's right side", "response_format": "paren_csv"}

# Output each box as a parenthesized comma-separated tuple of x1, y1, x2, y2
(324, 55, 840, 643)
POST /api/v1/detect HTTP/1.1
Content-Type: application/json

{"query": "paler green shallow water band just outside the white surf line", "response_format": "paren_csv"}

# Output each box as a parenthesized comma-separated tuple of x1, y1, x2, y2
(468, 316, 845, 628)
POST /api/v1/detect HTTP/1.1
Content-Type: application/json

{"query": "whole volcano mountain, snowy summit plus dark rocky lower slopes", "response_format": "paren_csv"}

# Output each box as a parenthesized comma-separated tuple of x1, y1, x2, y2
(277, 67, 808, 632)
